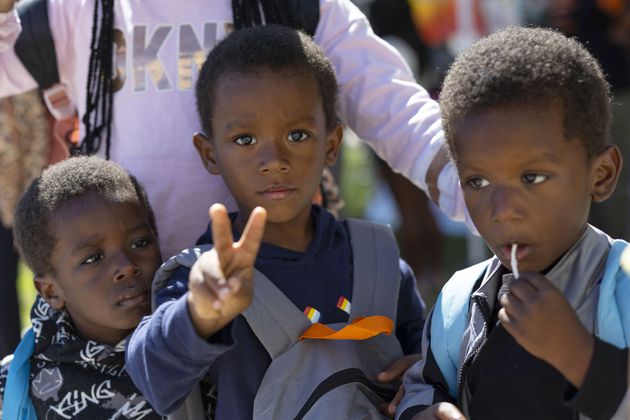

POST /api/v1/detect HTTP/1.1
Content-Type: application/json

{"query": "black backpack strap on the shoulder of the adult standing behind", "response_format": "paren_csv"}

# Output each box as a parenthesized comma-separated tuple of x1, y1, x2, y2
(14, 0, 59, 89)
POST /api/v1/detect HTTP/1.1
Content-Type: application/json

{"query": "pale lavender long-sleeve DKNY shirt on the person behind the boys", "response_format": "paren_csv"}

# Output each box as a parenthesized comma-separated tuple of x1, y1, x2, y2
(0, 0, 466, 258)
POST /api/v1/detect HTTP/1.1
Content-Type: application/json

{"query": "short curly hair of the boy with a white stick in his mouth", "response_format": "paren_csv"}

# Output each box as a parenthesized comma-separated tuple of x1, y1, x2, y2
(440, 27, 611, 161)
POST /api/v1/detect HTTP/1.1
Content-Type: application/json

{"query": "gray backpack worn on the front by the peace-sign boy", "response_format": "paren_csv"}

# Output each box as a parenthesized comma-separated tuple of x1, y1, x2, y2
(153, 219, 403, 419)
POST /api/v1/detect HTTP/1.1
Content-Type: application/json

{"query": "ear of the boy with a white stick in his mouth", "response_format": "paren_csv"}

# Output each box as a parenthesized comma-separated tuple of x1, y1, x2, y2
(591, 144, 623, 203)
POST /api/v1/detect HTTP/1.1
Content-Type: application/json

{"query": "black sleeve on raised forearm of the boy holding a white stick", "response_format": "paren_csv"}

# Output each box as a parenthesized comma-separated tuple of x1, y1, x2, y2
(565, 337, 628, 420)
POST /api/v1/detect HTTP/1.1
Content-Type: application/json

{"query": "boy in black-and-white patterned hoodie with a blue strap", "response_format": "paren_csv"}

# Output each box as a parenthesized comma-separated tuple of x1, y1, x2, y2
(0, 157, 162, 419)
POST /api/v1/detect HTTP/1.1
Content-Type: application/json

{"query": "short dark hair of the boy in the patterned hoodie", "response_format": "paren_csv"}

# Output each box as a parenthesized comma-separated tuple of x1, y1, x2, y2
(13, 156, 157, 275)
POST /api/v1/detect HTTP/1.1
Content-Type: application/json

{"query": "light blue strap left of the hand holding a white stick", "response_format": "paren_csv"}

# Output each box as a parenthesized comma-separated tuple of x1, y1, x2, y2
(431, 260, 490, 398)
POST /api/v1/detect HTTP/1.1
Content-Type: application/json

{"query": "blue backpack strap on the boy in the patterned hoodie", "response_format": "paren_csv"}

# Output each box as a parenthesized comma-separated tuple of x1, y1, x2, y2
(2, 328, 37, 420)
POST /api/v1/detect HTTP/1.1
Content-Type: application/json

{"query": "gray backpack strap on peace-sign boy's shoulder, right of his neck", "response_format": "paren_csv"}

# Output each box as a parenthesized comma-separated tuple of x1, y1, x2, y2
(348, 219, 400, 323)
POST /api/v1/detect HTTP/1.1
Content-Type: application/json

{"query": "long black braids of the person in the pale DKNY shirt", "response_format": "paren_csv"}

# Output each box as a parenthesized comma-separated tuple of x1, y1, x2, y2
(81, 0, 303, 159)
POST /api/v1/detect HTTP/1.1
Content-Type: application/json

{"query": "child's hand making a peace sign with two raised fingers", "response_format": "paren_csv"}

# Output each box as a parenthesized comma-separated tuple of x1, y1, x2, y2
(187, 204, 267, 338)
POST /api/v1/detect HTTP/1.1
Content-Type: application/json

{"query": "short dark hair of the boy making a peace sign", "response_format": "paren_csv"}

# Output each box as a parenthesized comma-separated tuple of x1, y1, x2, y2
(195, 25, 338, 138)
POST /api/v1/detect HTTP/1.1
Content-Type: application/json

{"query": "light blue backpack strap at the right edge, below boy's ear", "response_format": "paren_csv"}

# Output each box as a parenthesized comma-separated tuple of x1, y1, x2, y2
(597, 240, 630, 348)
